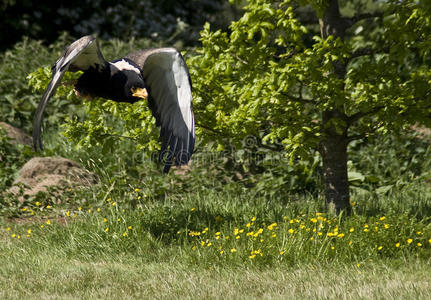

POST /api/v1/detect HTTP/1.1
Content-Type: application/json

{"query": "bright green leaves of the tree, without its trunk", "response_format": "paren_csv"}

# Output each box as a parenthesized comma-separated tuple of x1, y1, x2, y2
(189, 1, 431, 158)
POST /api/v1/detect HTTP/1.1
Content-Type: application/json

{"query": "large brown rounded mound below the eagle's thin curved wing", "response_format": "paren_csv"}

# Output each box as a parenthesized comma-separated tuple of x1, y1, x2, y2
(9, 157, 98, 196)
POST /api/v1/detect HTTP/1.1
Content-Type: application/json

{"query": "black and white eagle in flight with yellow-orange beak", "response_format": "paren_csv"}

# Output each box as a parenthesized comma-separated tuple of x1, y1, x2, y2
(33, 36, 195, 173)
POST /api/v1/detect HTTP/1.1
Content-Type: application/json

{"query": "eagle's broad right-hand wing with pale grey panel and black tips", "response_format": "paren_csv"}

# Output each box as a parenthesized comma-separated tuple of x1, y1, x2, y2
(126, 48, 195, 173)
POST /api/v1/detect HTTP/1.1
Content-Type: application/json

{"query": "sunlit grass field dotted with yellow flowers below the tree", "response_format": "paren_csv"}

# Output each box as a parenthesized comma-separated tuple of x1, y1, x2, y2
(0, 188, 431, 299)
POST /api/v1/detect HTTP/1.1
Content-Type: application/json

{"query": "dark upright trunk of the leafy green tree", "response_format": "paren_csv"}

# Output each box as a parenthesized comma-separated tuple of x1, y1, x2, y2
(319, 0, 351, 214)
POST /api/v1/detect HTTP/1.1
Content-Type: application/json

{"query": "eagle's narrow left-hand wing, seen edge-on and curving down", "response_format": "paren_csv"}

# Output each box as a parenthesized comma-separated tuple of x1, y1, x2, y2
(33, 36, 107, 150)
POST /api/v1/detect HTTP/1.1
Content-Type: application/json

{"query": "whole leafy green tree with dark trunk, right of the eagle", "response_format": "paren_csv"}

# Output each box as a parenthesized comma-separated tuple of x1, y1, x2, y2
(189, 0, 431, 213)
